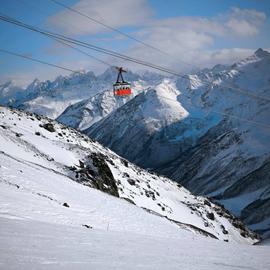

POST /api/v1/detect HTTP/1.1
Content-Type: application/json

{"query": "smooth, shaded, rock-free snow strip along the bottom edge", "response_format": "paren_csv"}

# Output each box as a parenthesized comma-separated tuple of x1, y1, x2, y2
(0, 218, 270, 270)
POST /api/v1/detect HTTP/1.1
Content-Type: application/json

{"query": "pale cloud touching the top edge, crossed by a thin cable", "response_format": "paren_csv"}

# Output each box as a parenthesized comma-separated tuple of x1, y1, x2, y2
(48, 0, 152, 35)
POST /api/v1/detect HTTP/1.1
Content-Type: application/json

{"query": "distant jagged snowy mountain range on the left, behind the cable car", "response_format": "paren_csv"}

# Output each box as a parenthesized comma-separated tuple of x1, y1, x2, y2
(0, 68, 162, 119)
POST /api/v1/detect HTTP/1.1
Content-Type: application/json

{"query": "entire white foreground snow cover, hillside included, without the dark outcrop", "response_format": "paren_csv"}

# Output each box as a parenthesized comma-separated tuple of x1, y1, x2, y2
(0, 107, 270, 270)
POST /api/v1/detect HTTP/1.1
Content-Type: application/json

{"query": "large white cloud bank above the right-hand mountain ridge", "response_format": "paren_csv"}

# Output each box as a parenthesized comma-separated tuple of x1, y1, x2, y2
(123, 8, 266, 71)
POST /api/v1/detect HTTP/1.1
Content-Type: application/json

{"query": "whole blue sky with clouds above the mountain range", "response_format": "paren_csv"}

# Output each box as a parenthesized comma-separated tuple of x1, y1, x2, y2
(0, 0, 270, 84)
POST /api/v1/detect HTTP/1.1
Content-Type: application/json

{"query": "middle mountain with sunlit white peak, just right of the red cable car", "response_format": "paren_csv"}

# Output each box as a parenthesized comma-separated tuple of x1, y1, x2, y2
(84, 80, 192, 168)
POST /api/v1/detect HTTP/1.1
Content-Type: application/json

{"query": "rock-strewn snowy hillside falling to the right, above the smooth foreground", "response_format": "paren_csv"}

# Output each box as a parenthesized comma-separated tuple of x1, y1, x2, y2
(0, 107, 257, 243)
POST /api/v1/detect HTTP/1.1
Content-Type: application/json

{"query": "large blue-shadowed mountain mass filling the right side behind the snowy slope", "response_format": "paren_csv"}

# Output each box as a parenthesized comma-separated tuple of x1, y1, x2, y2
(59, 49, 270, 236)
